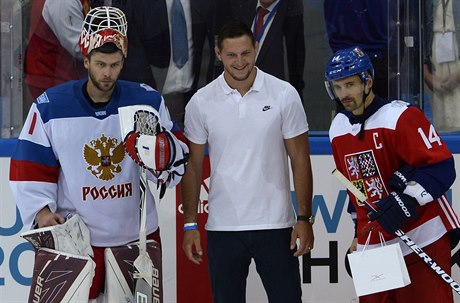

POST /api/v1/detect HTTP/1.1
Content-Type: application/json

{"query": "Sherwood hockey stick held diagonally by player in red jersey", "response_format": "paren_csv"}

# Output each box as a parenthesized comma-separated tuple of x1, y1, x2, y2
(332, 169, 460, 295)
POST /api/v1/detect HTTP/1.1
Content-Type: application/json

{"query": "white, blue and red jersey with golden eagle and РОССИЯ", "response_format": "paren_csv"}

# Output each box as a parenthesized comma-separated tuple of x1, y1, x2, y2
(10, 79, 178, 247)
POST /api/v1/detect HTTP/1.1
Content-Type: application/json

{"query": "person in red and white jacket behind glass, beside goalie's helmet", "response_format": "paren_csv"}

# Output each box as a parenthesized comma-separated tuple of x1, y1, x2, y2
(25, 0, 90, 102)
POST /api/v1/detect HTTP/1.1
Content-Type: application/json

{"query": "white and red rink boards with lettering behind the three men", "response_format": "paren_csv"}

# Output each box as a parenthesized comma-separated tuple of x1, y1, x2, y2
(0, 155, 460, 303)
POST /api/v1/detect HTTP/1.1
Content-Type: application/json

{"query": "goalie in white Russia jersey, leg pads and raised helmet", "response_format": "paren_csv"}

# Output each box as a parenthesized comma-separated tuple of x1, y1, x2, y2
(10, 6, 188, 303)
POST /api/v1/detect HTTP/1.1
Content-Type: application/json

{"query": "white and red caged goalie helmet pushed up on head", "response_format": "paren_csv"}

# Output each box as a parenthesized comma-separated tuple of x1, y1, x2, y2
(79, 6, 128, 58)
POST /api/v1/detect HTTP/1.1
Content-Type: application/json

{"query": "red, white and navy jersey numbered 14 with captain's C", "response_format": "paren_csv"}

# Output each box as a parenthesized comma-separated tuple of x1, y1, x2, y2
(329, 98, 460, 254)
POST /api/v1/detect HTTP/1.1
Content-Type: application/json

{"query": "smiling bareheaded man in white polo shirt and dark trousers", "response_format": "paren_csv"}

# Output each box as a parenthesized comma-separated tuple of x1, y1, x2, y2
(181, 21, 314, 303)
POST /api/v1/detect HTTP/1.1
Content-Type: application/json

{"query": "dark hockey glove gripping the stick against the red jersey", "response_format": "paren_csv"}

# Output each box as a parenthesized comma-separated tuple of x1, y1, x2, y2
(369, 191, 419, 234)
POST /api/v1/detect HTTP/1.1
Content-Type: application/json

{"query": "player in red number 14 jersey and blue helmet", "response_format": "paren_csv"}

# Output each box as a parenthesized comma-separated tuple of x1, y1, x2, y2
(325, 47, 460, 303)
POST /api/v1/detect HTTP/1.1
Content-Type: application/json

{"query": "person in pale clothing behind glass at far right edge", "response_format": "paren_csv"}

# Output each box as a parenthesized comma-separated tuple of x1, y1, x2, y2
(424, 0, 460, 132)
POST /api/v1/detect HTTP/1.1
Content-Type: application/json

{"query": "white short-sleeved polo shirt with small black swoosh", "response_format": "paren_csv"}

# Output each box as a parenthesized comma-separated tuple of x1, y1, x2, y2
(185, 69, 308, 231)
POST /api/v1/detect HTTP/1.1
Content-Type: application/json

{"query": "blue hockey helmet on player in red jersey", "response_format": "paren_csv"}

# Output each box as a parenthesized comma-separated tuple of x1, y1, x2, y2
(324, 46, 374, 99)
